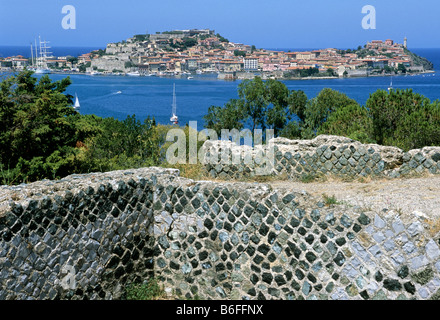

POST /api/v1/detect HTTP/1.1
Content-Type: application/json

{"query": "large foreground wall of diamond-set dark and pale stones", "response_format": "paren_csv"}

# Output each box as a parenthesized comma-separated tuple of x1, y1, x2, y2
(0, 168, 440, 299)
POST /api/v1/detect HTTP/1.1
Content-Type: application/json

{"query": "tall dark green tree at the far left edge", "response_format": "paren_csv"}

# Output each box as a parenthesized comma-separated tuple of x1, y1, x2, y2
(0, 70, 82, 182)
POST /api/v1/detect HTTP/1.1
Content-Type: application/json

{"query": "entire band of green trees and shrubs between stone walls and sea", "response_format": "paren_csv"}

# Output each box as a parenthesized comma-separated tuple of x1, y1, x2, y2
(4, 70, 440, 184)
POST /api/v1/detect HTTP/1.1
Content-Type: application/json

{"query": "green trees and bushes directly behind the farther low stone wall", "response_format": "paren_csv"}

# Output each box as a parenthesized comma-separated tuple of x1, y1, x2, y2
(205, 77, 440, 150)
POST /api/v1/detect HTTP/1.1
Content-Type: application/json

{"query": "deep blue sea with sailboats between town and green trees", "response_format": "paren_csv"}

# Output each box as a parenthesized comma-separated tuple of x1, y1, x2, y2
(0, 47, 440, 129)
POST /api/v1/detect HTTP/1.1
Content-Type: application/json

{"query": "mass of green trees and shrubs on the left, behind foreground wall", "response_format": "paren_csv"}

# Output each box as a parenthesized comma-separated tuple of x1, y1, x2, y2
(0, 71, 160, 184)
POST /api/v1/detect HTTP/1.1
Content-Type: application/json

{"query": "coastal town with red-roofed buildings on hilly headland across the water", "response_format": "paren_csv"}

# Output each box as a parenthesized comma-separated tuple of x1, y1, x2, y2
(0, 29, 433, 80)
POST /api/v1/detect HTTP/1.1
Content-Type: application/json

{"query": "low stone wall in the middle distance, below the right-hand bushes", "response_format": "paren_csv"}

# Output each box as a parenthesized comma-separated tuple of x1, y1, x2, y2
(204, 135, 440, 180)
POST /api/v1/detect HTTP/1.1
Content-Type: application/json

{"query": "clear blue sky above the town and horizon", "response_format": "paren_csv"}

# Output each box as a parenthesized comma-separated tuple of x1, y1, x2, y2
(0, 0, 440, 49)
